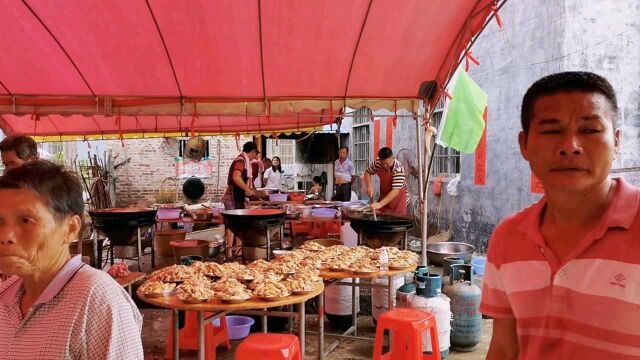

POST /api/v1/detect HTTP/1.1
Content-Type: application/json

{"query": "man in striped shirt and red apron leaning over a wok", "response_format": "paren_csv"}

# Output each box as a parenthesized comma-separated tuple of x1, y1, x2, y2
(364, 147, 409, 215)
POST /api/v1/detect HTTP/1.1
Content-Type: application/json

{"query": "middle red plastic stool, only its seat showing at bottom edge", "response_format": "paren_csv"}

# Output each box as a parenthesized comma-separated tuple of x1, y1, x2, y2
(235, 333, 302, 360)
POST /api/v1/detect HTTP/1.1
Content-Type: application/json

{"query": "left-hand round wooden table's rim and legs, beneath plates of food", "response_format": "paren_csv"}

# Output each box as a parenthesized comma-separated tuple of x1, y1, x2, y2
(138, 283, 324, 360)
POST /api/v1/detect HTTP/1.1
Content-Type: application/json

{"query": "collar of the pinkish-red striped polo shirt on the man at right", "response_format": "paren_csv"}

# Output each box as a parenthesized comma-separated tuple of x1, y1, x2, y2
(519, 178, 640, 245)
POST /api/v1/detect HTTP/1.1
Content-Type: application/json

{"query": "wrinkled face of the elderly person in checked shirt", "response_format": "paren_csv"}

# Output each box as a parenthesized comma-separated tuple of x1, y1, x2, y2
(0, 189, 80, 277)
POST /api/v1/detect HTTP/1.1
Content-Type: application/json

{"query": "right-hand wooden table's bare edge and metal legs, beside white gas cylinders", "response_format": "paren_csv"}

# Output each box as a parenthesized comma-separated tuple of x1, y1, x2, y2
(318, 265, 417, 359)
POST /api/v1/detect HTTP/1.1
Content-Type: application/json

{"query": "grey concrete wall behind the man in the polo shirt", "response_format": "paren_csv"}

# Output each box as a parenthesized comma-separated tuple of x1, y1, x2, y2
(446, 0, 640, 252)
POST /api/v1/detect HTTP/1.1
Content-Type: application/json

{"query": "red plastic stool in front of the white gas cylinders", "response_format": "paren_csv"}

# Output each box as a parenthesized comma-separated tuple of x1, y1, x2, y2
(373, 308, 441, 360)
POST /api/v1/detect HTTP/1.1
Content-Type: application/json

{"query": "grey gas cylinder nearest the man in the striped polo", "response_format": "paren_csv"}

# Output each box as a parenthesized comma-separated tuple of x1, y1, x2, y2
(443, 264, 482, 351)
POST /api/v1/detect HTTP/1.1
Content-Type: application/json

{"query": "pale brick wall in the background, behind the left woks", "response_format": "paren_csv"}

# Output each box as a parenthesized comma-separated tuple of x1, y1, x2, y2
(108, 136, 251, 207)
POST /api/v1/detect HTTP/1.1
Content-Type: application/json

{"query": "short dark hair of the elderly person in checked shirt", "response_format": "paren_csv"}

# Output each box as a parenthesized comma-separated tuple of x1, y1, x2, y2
(0, 160, 84, 222)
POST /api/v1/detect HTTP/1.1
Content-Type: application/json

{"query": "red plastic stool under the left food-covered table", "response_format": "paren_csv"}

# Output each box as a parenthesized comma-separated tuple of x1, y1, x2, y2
(165, 311, 231, 360)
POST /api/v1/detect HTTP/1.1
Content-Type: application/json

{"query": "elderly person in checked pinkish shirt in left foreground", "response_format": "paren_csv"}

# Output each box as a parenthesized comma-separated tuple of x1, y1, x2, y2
(0, 161, 143, 360)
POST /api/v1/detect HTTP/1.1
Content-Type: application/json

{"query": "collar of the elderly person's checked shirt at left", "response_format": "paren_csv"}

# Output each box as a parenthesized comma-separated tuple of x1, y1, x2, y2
(0, 255, 84, 306)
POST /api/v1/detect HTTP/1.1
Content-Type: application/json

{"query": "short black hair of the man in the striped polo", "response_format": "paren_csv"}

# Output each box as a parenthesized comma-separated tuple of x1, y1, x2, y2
(520, 71, 618, 134)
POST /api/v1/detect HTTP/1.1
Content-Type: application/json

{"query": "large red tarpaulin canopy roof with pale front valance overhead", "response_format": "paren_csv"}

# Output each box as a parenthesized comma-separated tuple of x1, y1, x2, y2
(0, 0, 495, 138)
